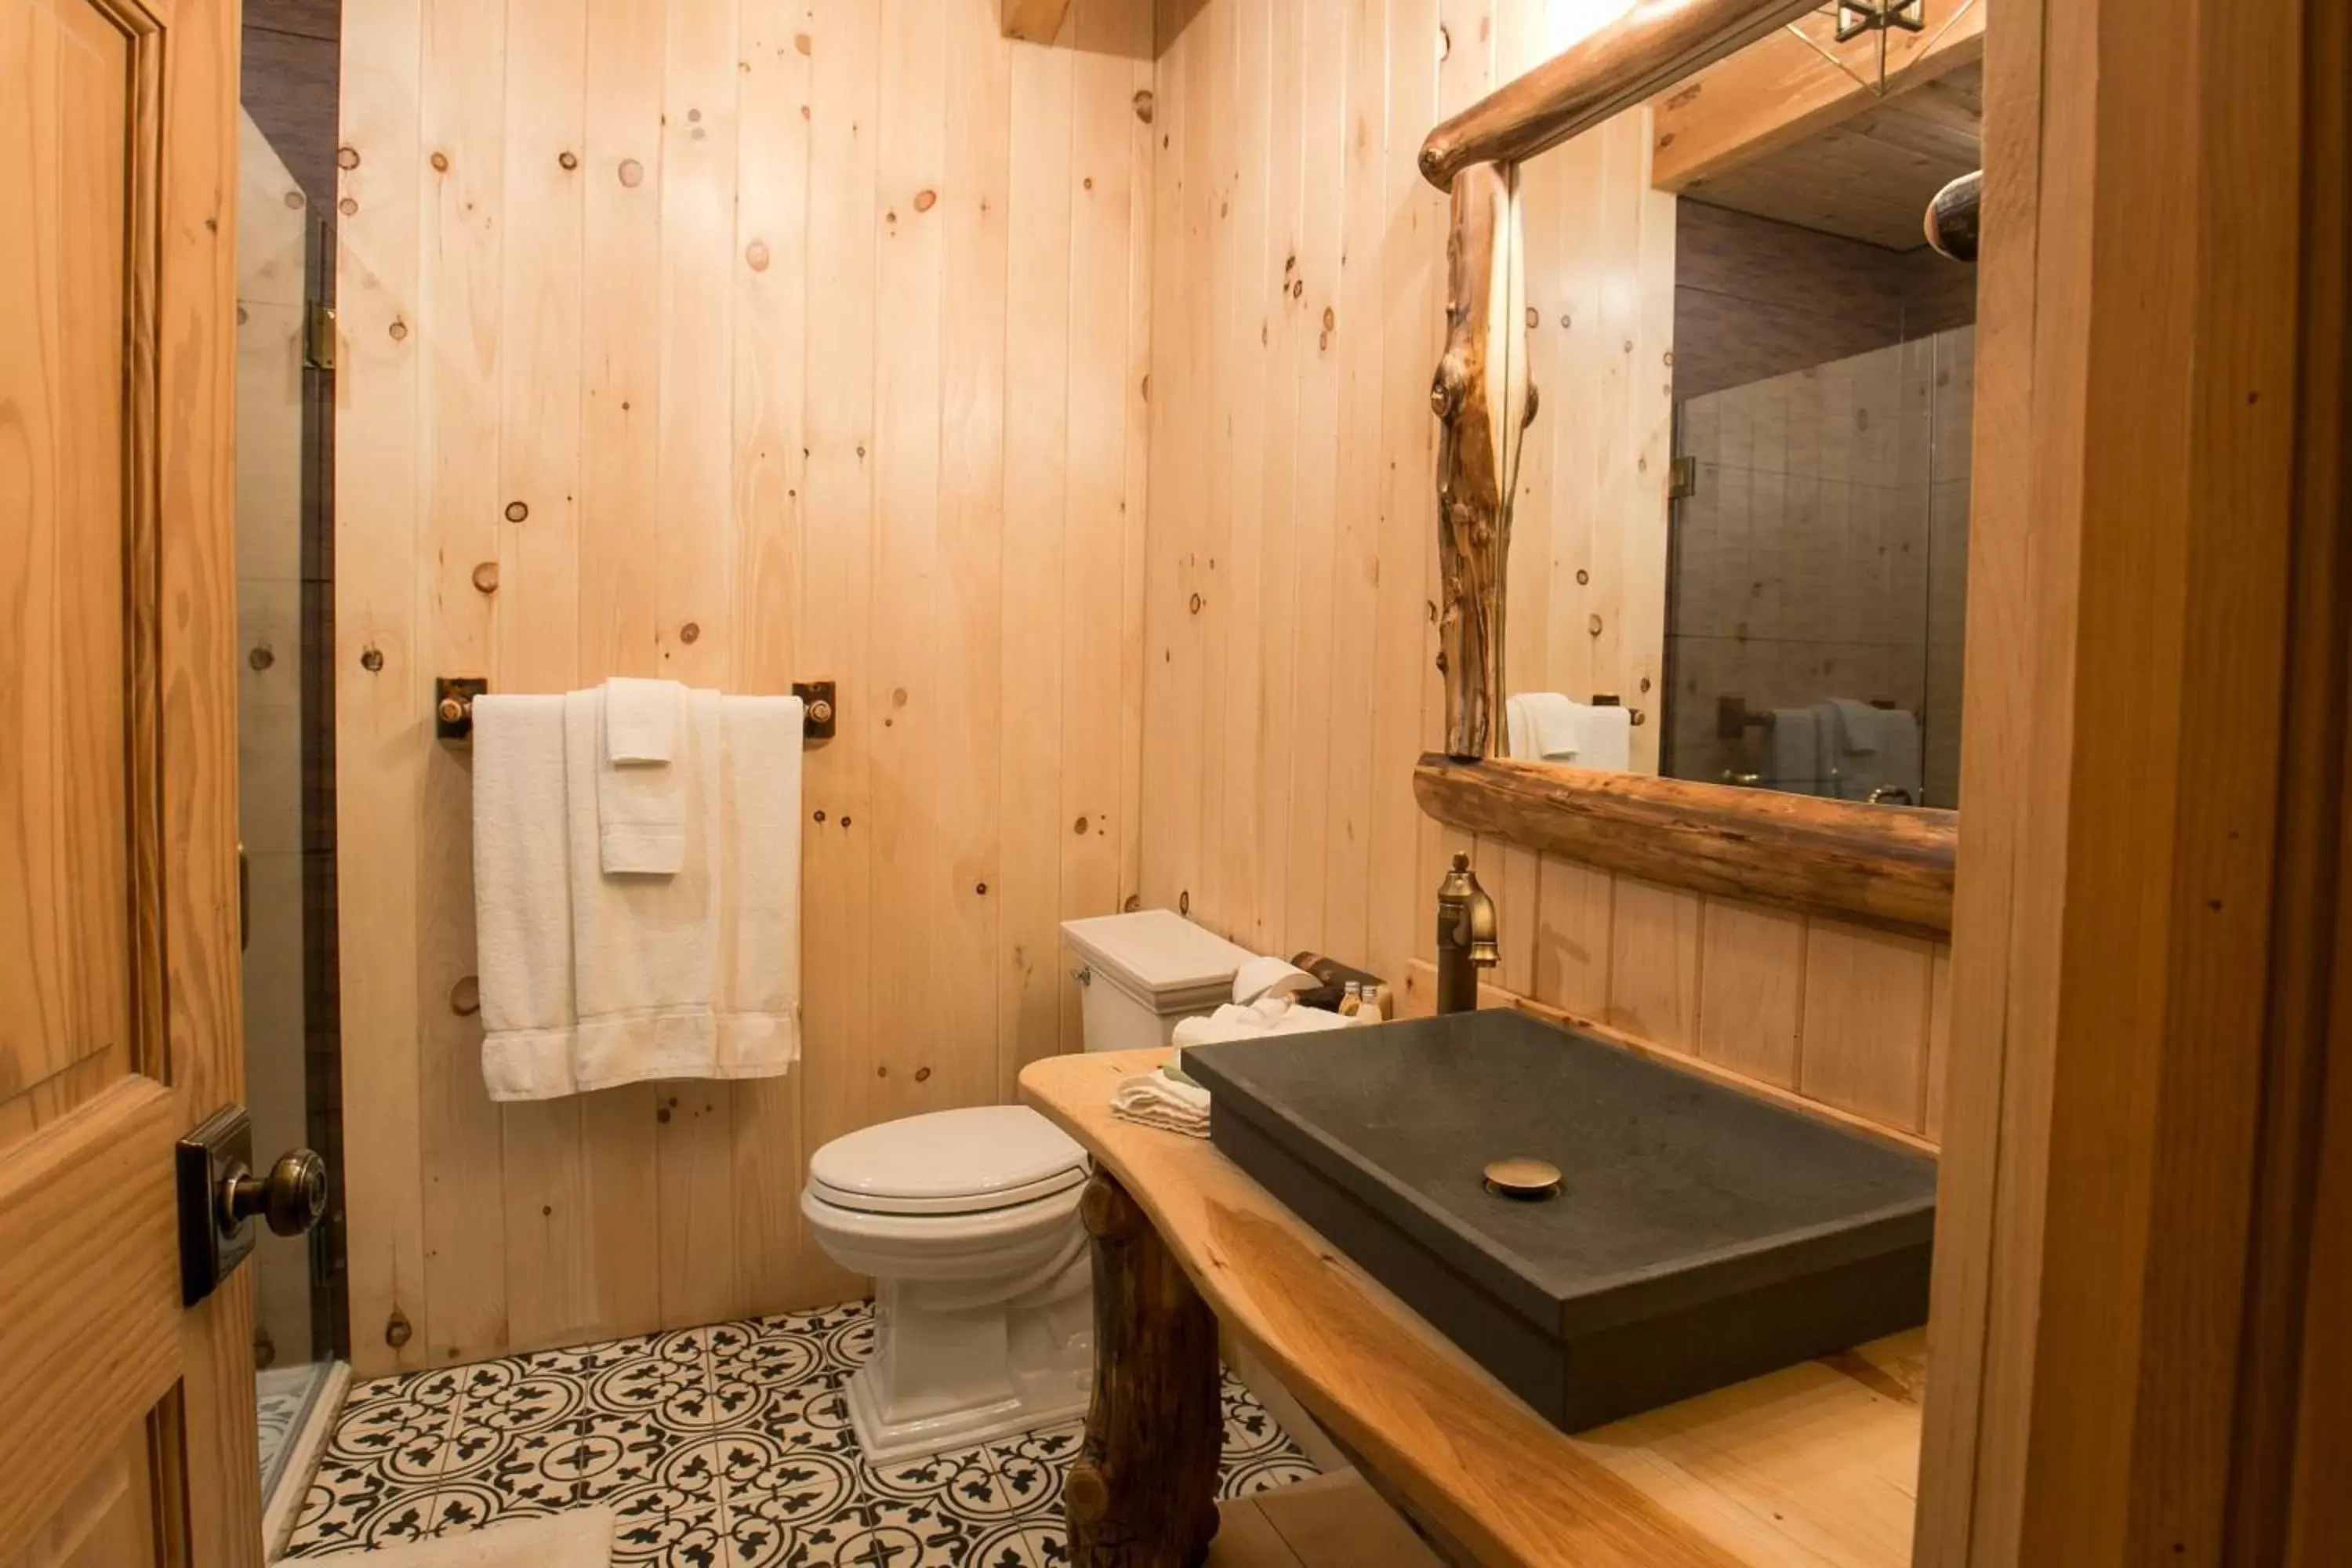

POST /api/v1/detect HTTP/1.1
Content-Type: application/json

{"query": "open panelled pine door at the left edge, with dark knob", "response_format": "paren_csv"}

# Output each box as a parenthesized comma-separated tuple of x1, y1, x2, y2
(0, 0, 261, 1568)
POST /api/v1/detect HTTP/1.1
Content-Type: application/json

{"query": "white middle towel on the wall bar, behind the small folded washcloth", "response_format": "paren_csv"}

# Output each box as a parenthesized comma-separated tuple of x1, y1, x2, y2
(564, 691, 722, 1093)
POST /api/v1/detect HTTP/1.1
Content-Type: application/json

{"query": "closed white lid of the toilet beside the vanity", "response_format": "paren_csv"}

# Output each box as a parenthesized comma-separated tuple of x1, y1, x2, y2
(809, 1105, 1087, 1213)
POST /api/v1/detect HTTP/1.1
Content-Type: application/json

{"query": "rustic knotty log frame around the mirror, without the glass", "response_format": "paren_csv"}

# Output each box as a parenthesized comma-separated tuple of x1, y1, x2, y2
(1414, 0, 1959, 935)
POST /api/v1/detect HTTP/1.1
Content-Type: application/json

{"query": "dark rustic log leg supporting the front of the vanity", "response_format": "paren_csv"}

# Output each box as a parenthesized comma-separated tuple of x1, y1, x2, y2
(1063, 1171, 1225, 1568)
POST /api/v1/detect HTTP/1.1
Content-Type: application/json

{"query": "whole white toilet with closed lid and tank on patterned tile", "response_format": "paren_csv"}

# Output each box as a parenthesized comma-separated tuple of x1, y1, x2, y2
(800, 909, 1251, 1462)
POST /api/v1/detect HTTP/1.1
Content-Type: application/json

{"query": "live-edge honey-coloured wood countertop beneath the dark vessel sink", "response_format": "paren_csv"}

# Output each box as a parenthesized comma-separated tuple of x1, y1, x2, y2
(1021, 1051, 1926, 1568)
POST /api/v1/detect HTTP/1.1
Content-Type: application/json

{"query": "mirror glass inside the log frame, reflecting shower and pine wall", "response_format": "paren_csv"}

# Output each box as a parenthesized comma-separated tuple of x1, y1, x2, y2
(1503, 35, 1983, 806)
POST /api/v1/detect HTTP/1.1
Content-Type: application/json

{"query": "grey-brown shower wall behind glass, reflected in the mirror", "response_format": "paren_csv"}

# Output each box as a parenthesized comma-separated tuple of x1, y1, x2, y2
(1665, 327, 1976, 806)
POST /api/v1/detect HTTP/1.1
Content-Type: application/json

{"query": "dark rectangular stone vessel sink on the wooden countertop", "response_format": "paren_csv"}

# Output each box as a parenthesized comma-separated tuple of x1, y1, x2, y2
(1183, 1011, 1936, 1432)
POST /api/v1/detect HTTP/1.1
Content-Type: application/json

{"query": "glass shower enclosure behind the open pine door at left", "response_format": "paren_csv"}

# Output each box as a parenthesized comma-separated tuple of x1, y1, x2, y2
(238, 115, 348, 1523)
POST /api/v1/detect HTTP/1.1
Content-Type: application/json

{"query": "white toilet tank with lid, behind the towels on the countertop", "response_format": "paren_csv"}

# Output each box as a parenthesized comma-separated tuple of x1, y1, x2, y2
(1061, 909, 1254, 1051)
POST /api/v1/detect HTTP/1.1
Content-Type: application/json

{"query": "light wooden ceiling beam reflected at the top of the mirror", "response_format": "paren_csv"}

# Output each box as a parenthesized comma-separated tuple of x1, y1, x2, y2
(1649, 0, 1987, 191)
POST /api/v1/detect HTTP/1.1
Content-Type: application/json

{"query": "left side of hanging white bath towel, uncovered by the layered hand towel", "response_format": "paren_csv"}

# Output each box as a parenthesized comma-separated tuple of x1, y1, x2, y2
(473, 696, 579, 1100)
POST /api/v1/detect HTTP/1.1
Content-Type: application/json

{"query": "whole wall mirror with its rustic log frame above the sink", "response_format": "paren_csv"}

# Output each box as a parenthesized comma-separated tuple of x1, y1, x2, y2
(1416, 0, 1987, 933)
